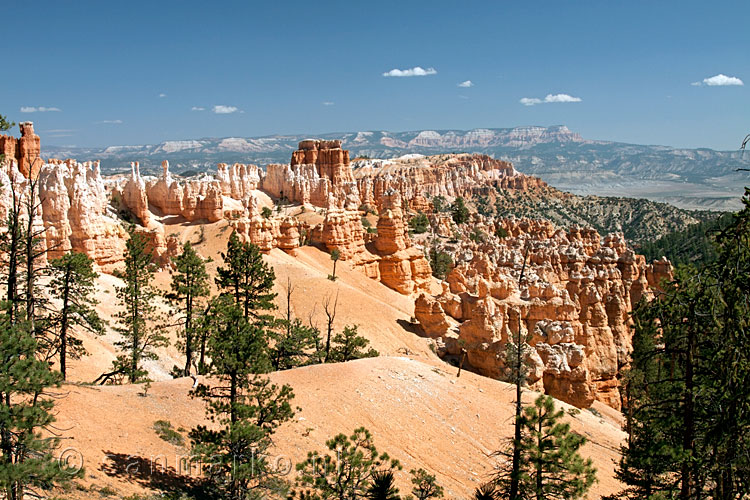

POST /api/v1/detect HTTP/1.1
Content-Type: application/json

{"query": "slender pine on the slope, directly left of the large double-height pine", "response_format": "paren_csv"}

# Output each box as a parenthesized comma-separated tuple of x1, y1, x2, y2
(167, 241, 209, 376)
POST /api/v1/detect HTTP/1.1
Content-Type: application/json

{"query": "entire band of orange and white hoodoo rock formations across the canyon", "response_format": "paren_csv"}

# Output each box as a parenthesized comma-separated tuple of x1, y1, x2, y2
(0, 124, 671, 409)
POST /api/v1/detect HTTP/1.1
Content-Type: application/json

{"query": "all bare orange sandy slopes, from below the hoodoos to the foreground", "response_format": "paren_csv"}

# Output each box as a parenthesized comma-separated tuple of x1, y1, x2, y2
(51, 221, 623, 499)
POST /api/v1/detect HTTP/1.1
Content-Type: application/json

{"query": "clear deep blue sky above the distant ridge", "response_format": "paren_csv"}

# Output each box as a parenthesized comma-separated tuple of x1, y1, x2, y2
(0, 0, 750, 149)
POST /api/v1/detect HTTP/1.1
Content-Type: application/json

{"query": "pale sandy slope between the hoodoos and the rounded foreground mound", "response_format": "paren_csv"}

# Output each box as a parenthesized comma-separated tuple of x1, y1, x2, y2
(69, 221, 435, 382)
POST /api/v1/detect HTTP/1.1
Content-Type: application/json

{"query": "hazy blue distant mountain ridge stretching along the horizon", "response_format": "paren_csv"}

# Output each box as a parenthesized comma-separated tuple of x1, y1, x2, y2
(42, 125, 750, 210)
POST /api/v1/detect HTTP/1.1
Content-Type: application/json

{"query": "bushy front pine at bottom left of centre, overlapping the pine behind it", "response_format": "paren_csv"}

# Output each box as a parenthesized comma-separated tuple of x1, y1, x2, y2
(190, 297, 294, 500)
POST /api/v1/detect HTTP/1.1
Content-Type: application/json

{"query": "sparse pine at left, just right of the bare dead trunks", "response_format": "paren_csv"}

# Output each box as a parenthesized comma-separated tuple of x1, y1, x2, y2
(49, 252, 104, 380)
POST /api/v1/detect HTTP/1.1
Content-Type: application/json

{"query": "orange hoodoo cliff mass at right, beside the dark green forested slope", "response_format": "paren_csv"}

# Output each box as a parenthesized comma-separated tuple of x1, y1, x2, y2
(415, 215, 671, 409)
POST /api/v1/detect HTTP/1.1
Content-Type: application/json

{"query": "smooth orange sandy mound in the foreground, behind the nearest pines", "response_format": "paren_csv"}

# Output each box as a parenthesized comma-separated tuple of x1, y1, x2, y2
(58, 357, 623, 498)
